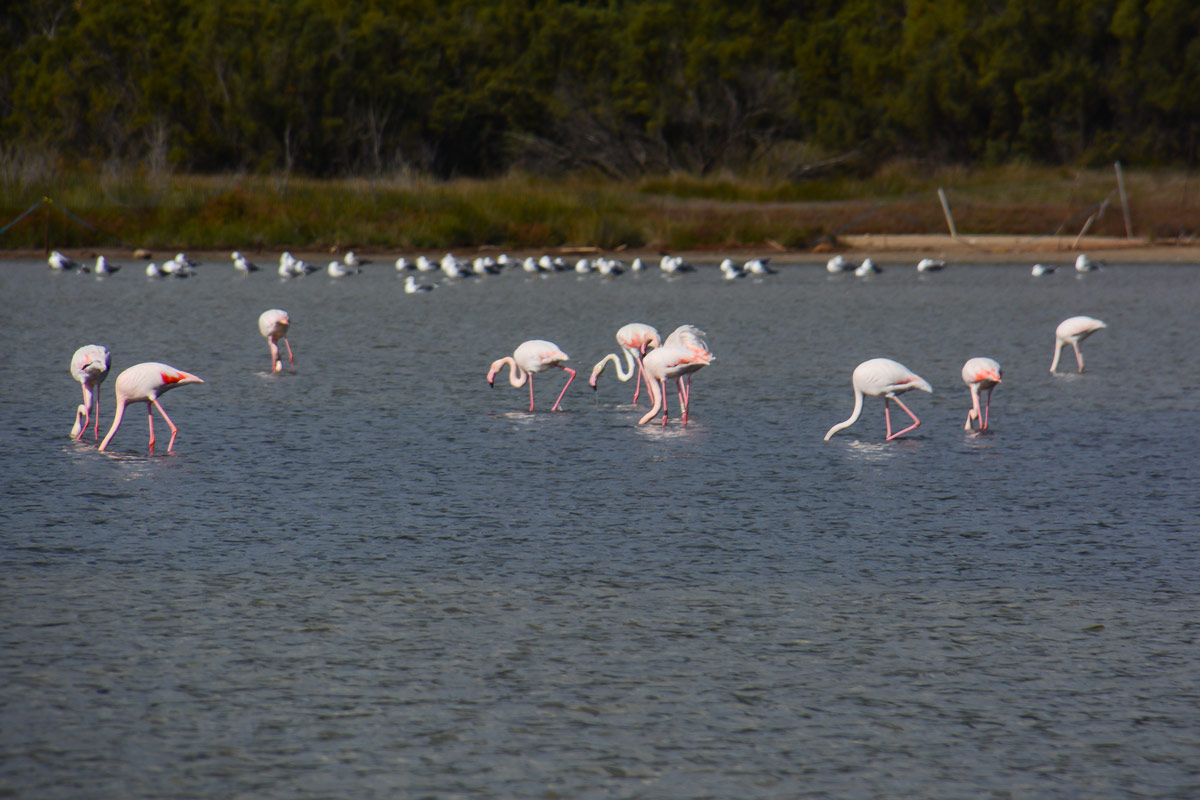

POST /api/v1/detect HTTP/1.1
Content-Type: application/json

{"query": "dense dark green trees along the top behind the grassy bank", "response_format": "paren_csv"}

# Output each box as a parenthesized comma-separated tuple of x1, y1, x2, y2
(0, 0, 1200, 176)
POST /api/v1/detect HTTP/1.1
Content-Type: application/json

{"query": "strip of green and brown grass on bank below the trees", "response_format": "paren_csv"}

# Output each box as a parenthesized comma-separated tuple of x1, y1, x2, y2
(7, 162, 1200, 252)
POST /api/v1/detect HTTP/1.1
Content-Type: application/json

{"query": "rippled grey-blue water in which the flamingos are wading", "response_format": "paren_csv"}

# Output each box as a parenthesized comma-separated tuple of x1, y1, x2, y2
(0, 261, 1200, 799)
